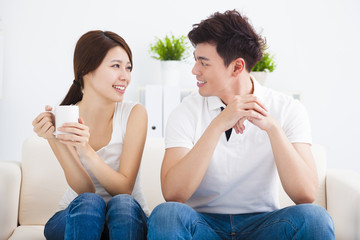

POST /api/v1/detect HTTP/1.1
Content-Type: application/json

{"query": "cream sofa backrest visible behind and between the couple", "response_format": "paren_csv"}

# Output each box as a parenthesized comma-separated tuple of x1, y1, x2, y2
(19, 137, 326, 226)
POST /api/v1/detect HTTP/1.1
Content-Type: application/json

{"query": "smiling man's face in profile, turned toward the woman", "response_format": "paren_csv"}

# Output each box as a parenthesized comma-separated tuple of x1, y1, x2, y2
(192, 43, 232, 98)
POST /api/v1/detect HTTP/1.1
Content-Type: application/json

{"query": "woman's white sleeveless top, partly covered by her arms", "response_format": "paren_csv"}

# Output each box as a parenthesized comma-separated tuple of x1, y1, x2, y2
(57, 102, 150, 216)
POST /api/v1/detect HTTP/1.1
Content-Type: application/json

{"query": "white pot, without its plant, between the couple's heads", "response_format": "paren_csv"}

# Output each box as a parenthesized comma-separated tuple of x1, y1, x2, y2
(161, 60, 183, 87)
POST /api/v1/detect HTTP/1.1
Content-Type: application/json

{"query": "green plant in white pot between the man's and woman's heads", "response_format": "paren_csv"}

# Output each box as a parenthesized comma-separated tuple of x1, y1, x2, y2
(150, 34, 190, 86)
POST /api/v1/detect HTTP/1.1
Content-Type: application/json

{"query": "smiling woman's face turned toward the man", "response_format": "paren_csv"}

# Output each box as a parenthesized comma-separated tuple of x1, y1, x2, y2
(84, 46, 132, 102)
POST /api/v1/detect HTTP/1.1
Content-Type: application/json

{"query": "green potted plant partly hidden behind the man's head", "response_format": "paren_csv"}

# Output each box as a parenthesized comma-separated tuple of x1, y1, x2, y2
(251, 52, 276, 85)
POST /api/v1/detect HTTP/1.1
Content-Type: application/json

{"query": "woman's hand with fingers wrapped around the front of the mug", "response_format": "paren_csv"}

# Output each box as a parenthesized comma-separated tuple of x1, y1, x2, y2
(57, 117, 90, 154)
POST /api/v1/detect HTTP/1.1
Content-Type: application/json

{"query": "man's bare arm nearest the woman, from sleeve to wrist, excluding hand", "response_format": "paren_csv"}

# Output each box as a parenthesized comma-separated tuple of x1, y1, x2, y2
(161, 121, 223, 202)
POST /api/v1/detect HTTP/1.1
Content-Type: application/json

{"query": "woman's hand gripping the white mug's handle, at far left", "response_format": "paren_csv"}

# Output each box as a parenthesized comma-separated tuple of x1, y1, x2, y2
(32, 105, 56, 140)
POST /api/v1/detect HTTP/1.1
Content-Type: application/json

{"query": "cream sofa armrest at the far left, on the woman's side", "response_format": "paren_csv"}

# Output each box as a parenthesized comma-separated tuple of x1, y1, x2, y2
(0, 161, 21, 239)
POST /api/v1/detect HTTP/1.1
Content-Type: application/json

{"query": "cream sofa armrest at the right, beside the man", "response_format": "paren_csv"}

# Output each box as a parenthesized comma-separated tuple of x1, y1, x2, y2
(326, 169, 360, 239)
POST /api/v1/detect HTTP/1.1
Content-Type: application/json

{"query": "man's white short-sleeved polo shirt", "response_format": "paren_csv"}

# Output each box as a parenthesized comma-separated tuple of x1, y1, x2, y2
(165, 78, 311, 214)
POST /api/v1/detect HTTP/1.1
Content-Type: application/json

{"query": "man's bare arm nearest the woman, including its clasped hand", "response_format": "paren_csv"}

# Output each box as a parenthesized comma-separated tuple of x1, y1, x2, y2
(161, 95, 267, 202)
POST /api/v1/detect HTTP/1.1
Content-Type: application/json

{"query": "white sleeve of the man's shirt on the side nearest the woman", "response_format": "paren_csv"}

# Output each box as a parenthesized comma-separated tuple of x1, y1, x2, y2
(165, 104, 196, 149)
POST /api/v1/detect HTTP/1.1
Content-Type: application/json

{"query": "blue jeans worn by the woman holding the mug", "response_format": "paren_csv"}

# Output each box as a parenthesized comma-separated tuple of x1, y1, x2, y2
(44, 193, 147, 240)
